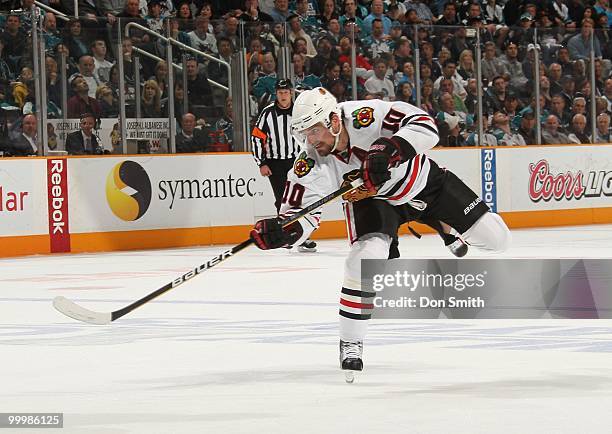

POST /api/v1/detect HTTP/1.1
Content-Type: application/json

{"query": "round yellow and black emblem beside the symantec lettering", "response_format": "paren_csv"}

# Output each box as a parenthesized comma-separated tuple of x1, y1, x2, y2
(106, 160, 151, 221)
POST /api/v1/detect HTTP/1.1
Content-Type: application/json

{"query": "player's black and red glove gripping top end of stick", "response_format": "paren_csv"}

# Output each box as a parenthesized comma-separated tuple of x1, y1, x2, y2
(361, 137, 402, 193)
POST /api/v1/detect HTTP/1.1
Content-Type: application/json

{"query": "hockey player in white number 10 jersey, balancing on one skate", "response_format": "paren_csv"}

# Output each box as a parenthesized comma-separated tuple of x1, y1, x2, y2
(251, 88, 510, 382)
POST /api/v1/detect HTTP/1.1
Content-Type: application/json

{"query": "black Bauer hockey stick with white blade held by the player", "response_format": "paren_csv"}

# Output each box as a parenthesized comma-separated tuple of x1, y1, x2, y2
(53, 179, 363, 324)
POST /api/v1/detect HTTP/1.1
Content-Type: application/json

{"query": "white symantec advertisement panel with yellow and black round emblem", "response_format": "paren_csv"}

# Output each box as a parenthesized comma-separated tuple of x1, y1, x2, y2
(68, 155, 276, 233)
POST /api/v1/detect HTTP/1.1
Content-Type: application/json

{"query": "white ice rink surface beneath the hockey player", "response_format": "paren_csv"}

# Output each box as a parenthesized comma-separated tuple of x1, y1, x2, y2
(0, 225, 612, 434)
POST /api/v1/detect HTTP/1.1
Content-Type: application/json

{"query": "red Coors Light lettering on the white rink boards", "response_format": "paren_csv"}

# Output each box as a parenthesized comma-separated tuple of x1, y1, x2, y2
(529, 160, 612, 202)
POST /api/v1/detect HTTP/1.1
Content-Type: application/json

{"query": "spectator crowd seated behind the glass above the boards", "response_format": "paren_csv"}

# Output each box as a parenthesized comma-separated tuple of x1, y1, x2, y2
(0, 0, 612, 154)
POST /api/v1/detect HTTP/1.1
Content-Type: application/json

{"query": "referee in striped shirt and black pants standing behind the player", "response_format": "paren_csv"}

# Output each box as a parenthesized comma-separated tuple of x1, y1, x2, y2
(251, 79, 317, 251)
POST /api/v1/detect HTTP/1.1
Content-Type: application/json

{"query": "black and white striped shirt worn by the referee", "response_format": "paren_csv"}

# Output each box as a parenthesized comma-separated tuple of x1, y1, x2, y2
(251, 103, 300, 167)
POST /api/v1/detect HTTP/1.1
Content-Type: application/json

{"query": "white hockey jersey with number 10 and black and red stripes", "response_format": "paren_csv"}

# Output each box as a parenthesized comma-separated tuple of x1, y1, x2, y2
(280, 100, 438, 244)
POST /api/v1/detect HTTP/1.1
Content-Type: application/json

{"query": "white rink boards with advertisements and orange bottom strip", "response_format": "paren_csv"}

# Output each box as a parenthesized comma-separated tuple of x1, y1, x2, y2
(0, 145, 612, 256)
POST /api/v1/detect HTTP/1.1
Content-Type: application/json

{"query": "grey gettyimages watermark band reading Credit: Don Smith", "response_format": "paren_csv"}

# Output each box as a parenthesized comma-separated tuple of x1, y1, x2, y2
(362, 259, 612, 318)
